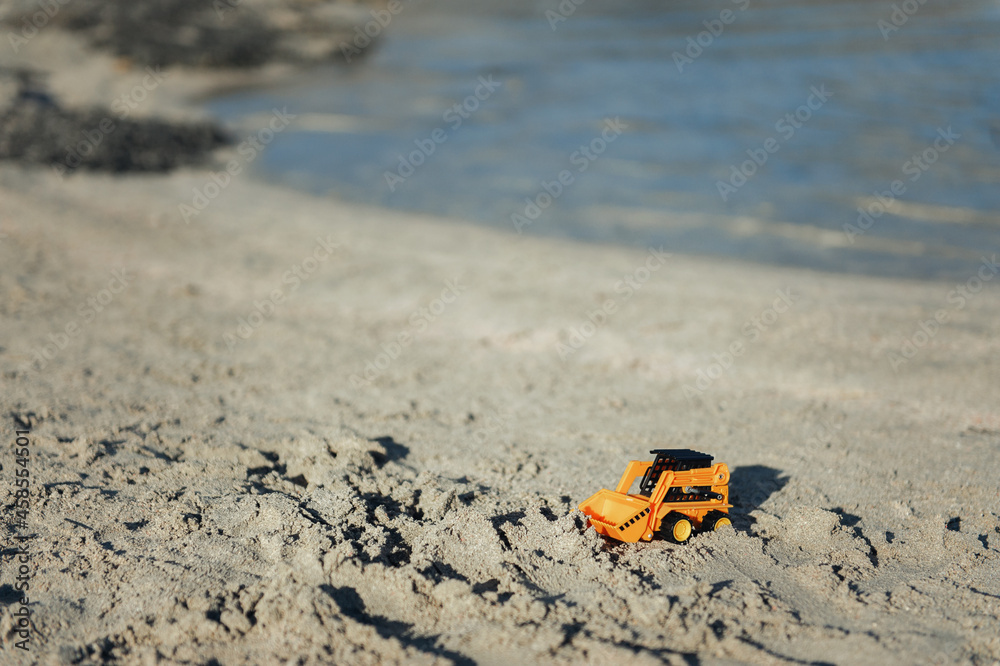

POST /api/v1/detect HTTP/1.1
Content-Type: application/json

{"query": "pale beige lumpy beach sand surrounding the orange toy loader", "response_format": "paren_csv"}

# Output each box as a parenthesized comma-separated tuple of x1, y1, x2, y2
(0, 14, 1000, 664)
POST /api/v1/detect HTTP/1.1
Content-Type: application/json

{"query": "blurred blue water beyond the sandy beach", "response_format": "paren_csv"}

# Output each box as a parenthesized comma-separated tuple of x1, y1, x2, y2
(209, 0, 1000, 277)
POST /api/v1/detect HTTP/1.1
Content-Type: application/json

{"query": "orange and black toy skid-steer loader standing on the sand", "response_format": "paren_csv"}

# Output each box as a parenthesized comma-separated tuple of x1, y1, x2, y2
(580, 449, 732, 543)
